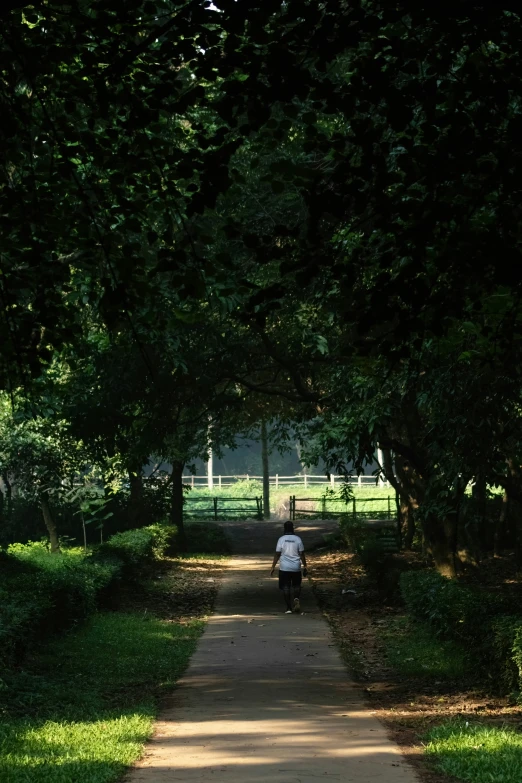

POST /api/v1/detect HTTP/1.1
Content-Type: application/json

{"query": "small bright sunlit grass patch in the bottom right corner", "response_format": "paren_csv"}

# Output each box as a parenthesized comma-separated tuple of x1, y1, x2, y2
(424, 720, 522, 783)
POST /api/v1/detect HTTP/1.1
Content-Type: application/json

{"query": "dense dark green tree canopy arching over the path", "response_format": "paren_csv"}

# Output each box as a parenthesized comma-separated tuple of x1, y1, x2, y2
(0, 0, 522, 575)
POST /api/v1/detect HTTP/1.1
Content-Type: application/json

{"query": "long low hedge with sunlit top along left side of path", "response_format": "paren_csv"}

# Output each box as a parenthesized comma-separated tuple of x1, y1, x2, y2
(0, 525, 175, 666)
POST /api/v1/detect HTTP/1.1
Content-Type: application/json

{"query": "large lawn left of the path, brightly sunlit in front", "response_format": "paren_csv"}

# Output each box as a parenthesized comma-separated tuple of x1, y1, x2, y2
(0, 613, 203, 783)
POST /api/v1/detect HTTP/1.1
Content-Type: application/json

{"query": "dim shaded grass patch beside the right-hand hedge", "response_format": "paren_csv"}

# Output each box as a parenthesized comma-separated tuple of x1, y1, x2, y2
(382, 618, 473, 680)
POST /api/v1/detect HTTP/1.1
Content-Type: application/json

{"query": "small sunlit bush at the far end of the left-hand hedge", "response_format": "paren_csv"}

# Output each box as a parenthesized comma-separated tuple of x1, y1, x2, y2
(96, 524, 177, 579)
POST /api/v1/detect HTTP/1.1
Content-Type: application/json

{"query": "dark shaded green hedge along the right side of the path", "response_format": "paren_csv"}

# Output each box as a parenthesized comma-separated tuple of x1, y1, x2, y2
(400, 571, 522, 691)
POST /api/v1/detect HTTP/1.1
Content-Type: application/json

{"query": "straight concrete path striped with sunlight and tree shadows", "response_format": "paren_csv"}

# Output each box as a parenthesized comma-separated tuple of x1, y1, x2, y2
(126, 523, 417, 783)
